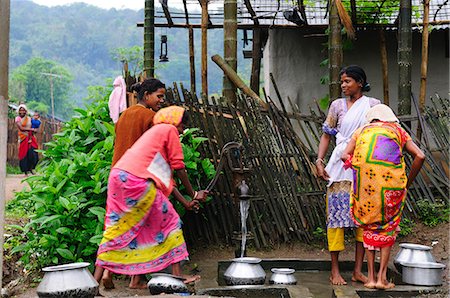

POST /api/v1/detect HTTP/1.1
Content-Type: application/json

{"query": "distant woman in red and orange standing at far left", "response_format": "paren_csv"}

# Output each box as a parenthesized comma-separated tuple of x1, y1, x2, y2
(15, 104, 38, 175)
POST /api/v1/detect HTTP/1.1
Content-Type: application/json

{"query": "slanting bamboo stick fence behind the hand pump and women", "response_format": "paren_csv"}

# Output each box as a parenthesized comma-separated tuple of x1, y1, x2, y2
(166, 84, 449, 248)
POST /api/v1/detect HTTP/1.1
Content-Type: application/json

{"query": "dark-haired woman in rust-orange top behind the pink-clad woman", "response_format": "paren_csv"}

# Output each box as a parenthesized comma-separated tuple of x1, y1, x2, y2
(94, 78, 166, 289)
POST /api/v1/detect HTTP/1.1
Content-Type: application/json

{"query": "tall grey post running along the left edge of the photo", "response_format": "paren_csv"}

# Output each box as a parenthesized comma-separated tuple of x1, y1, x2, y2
(0, 0, 10, 287)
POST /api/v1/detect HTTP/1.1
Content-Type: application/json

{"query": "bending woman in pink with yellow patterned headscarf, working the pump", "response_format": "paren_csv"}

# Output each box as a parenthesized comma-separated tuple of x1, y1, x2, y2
(96, 106, 207, 288)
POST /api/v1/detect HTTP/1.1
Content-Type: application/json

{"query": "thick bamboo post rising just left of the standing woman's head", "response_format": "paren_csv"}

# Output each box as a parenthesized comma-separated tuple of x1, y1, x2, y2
(328, 0, 343, 101)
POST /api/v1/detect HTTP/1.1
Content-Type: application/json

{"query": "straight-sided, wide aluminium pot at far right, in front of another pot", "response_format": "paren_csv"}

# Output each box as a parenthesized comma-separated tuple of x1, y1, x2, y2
(402, 262, 445, 286)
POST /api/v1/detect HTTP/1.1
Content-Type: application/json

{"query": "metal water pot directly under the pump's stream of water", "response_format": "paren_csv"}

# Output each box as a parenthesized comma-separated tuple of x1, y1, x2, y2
(223, 257, 266, 286)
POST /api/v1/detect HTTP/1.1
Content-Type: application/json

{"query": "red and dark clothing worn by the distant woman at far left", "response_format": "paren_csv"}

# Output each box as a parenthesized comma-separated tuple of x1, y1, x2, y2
(16, 116, 39, 173)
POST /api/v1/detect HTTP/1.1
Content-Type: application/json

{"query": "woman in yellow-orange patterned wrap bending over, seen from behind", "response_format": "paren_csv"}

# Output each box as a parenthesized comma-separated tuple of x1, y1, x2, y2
(342, 104, 425, 289)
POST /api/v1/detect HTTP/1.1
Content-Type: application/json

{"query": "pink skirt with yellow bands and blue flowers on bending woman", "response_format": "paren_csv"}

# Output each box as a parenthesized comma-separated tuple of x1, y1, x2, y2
(96, 168, 188, 275)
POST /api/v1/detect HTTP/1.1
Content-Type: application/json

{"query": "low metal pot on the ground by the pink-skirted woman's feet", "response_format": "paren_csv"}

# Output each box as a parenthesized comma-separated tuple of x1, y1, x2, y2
(147, 273, 189, 295)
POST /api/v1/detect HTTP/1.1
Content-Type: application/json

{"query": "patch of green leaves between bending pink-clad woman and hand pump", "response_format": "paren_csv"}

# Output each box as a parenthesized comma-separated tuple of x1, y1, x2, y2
(172, 128, 216, 216)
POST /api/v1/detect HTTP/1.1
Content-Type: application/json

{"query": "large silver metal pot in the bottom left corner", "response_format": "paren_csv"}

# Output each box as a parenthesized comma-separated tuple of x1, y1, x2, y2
(36, 262, 98, 298)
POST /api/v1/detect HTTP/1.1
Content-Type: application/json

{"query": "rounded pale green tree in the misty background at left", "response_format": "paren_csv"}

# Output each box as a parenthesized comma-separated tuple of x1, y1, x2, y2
(10, 57, 73, 118)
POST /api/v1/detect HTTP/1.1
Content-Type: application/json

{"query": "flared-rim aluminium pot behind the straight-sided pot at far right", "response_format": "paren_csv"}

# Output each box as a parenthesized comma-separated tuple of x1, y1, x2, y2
(394, 243, 436, 272)
